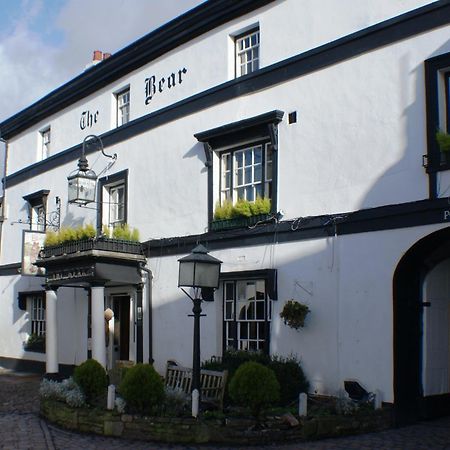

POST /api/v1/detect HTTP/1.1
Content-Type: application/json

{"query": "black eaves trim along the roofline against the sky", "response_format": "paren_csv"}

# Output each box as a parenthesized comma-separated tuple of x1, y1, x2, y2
(0, 0, 274, 139)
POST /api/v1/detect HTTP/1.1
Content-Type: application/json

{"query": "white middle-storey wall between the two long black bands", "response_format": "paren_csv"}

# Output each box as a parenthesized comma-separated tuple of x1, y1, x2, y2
(3, 27, 450, 263)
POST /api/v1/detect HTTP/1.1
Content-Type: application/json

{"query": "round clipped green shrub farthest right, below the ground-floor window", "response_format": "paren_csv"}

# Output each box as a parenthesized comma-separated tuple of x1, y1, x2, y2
(229, 361, 280, 418)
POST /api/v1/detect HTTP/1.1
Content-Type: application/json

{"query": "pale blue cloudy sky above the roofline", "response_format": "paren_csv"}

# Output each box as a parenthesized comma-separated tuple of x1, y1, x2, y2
(0, 0, 203, 122)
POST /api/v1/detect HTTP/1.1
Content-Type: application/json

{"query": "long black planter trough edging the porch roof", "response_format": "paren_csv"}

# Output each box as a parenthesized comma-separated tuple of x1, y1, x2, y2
(39, 237, 143, 259)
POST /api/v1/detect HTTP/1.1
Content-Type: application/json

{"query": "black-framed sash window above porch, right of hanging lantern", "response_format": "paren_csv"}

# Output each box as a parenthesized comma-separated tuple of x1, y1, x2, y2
(99, 171, 127, 232)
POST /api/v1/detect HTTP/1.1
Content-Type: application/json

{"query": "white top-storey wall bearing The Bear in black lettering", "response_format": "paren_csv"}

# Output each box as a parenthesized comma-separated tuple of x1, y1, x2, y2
(4, 0, 431, 174)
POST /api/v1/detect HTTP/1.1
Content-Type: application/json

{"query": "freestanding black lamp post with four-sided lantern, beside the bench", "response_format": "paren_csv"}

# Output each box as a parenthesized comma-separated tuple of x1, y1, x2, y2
(178, 245, 222, 402)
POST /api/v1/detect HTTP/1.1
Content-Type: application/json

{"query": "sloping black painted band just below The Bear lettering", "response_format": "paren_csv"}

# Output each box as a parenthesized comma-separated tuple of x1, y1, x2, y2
(4, 0, 450, 186)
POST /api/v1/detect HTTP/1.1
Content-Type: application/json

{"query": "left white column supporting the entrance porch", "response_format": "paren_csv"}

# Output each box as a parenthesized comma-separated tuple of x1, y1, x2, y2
(45, 286, 59, 373)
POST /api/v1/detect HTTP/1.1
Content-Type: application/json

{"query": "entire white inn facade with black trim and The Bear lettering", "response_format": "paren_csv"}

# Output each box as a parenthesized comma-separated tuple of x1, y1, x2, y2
(0, 0, 450, 417)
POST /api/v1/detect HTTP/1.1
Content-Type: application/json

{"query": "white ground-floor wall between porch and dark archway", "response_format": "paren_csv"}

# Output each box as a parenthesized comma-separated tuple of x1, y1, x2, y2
(149, 221, 450, 402)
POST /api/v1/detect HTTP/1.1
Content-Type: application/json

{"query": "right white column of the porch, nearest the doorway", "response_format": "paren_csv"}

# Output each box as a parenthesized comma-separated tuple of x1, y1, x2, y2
(91, 286, 106, 369)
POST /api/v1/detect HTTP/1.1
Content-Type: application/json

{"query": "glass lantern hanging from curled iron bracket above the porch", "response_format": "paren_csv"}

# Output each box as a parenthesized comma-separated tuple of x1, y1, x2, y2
(67, 134, 117, 205)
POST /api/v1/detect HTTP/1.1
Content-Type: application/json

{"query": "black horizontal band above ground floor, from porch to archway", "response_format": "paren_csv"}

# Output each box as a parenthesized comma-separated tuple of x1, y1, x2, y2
(144, 198, 450, 258)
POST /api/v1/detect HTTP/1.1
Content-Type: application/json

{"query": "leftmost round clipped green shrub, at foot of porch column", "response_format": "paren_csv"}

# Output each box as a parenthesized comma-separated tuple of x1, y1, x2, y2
(73, 359, 108, 405)
